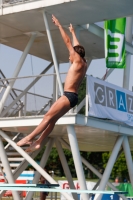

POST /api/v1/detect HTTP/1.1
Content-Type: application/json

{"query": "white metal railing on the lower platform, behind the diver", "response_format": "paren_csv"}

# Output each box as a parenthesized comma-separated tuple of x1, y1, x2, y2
(0, 71, 88, 117)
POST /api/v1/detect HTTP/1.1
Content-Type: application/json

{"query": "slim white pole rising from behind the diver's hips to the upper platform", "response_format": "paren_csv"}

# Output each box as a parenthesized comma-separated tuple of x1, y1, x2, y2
(43, 10, 63, 95)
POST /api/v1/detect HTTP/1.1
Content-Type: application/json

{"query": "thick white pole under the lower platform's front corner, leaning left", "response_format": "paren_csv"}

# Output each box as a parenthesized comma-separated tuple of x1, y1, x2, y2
(67, 125, 89, 200)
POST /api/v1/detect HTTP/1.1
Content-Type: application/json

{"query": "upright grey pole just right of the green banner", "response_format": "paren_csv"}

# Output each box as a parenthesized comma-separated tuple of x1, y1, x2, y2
(123, 17, 133, 89)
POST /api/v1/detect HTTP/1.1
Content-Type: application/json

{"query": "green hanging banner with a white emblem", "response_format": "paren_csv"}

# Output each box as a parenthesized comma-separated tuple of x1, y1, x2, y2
(104, 18, 126, 68)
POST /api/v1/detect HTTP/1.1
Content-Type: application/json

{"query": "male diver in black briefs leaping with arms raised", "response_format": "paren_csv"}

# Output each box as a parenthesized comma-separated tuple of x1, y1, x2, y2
(17, 15, 87, 152)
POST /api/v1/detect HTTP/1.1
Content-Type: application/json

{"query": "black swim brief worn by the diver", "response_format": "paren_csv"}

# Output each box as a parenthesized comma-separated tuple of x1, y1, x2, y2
(64, 92, 78, 108)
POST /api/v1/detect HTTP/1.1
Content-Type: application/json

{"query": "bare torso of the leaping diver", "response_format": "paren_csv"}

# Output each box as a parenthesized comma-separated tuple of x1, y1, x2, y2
(64, 57, 87, 93)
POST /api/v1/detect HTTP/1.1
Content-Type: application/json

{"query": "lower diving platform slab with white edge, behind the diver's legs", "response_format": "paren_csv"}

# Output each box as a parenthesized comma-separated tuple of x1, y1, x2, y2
(0, 114, 133, 152)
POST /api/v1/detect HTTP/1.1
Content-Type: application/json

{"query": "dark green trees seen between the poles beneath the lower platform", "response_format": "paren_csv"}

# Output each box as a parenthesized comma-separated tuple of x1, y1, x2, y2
(35, 144, 133, 180)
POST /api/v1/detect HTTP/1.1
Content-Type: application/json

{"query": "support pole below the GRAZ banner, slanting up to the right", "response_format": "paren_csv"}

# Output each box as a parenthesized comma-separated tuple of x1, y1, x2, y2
(94, 136, 124, 200)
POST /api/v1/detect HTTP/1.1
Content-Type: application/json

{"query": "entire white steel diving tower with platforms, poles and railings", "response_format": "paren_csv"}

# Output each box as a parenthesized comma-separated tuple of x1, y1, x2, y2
(0, 0, 133, 200)
